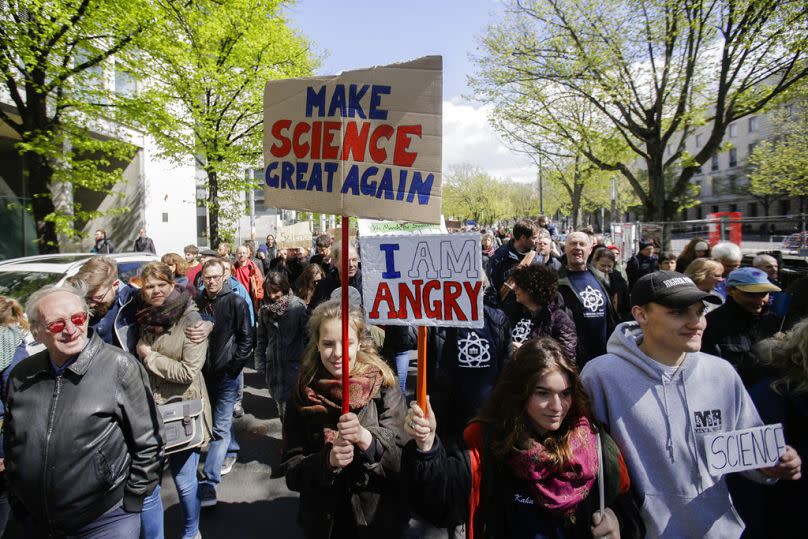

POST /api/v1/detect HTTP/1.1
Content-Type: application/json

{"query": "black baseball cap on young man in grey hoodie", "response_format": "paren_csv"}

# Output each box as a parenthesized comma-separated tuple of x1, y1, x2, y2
(631, 271, 721, 309)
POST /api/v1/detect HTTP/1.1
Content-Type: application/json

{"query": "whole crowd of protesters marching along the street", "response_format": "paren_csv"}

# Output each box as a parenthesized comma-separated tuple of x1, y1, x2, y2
(0, 217, 808, 539)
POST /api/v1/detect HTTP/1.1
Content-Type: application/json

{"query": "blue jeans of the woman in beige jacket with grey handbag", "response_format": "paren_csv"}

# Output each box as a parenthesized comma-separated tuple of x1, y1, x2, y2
(140, 449, 201, 539)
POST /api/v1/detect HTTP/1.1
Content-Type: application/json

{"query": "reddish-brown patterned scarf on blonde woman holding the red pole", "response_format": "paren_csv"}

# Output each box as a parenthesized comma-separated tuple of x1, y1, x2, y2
(297, 367, 382, 443)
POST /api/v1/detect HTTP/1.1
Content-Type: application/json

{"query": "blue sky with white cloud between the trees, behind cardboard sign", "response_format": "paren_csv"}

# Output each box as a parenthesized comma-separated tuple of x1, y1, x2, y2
(280, 0, 536, 181)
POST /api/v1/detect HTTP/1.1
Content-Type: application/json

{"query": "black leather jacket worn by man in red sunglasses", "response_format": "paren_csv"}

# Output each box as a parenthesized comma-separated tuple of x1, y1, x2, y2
(4, 335, 163, 535)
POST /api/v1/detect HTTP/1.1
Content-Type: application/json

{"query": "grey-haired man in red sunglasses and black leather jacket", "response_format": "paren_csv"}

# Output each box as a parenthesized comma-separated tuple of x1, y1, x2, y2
(4, 285, 163, 539)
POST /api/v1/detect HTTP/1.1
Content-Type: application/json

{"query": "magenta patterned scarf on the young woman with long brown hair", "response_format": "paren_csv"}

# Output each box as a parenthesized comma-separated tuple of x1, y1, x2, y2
(508, 417, 599, 517)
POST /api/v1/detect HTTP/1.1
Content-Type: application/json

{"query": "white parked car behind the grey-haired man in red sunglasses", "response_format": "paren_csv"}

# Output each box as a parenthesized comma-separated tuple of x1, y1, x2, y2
(0, 253, 160, 305)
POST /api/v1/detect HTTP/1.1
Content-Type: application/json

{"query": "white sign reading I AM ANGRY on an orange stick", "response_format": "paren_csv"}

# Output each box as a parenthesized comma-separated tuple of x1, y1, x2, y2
(362, 234, 483, 328)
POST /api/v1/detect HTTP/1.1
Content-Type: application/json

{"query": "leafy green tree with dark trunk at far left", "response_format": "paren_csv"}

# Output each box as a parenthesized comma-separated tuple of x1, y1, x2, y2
(0, 0, 161, 252)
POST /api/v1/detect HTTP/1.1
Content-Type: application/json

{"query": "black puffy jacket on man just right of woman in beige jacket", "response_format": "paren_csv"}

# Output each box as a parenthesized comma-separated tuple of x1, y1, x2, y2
(196, 281, 255, 378)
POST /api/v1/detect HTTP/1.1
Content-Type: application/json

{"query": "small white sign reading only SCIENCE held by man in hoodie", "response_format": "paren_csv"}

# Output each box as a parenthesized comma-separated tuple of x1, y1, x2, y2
(704, 423, 786, 476)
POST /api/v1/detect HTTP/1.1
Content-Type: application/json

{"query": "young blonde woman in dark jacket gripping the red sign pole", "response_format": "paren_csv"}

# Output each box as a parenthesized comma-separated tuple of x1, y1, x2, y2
(282, 300, 409, 538)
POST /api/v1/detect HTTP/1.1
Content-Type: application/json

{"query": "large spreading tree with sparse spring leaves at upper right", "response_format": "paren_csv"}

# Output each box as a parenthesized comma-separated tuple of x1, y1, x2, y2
(472, 0, 808, 247)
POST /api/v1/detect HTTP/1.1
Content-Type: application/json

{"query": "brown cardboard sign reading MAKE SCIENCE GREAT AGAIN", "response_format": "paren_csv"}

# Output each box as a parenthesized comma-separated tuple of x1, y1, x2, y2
(264, 56, 443, 223)
